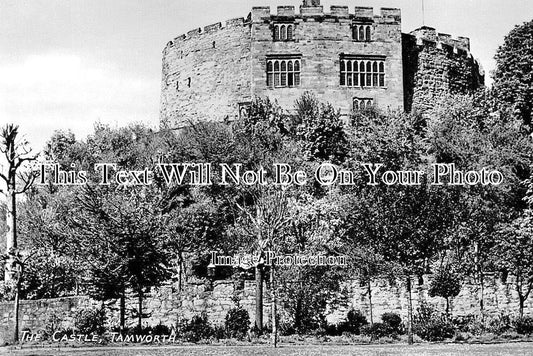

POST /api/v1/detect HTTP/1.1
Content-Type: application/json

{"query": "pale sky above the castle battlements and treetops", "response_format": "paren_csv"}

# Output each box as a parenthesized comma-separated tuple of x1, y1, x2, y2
(0, 0, 533, 150)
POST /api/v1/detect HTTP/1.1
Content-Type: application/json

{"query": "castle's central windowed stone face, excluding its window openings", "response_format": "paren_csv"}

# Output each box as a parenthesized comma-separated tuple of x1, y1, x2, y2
(251, 6, 403, 114)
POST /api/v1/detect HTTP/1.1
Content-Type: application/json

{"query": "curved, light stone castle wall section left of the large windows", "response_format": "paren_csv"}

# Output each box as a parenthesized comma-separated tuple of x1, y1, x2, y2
(160, 18, 251, 128)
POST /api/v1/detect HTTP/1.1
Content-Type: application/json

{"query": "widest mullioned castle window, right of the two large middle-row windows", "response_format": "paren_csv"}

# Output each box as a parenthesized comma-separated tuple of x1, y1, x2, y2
(340, 56, 385, 87)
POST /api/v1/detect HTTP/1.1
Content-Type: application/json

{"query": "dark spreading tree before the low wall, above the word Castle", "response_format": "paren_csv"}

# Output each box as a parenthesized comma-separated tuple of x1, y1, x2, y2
(72, 186, 170, 329)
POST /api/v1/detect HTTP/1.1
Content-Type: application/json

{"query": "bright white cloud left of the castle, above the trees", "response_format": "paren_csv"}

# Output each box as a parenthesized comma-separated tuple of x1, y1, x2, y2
(0, 53, 160, 148)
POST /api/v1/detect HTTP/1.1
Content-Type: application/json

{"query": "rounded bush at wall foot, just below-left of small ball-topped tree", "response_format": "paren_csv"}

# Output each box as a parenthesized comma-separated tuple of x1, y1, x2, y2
(413, 304, 455, 341)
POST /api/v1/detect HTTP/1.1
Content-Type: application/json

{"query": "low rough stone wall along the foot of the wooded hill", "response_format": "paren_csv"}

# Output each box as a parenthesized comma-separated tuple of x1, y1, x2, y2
(0, 275, 533, 344)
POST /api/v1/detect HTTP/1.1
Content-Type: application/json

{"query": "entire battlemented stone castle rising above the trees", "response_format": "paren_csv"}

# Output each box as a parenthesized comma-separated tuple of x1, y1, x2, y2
(160, 0, 484, 128)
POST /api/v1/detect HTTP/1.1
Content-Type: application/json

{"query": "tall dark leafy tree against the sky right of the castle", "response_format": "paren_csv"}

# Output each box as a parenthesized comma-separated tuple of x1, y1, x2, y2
(493, 20, 533, 130)
